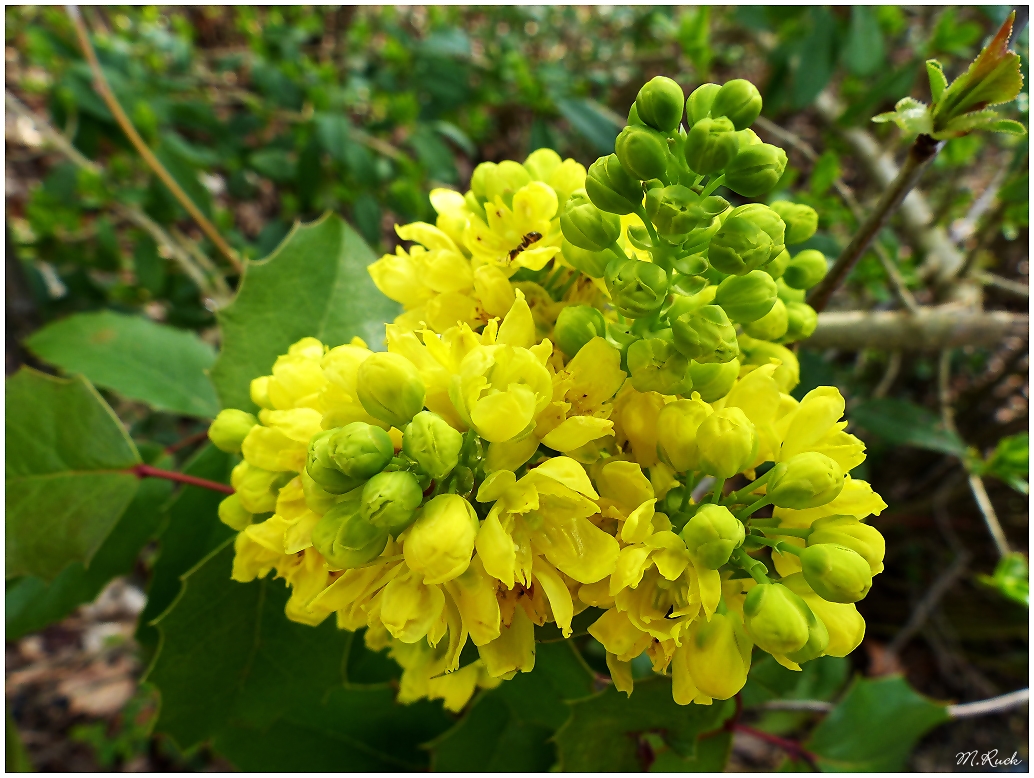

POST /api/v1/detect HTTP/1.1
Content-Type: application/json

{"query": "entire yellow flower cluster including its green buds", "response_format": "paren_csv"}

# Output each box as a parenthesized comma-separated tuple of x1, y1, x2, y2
(210, 72, 886, 710)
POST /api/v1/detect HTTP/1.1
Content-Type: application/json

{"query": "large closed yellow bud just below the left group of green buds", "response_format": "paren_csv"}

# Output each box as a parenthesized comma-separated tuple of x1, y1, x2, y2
(402, 495, 478, 585)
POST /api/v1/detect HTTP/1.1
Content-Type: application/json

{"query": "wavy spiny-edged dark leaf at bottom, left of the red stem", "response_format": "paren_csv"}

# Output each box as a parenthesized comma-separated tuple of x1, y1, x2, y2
(555, 677, 734, 772)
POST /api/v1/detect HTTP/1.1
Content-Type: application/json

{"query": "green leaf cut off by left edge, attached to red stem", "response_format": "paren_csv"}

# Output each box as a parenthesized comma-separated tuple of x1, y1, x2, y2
(4, 368, 140, 580)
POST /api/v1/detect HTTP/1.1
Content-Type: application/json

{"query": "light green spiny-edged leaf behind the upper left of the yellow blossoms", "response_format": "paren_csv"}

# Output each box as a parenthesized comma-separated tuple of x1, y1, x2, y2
(212, 213, 399, 411)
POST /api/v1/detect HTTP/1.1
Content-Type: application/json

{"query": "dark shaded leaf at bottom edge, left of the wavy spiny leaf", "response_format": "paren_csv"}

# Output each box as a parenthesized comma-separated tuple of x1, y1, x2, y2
(428, 640, 592, 773)
